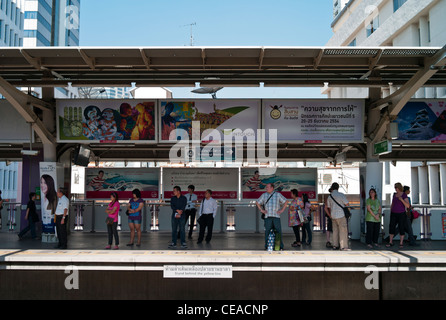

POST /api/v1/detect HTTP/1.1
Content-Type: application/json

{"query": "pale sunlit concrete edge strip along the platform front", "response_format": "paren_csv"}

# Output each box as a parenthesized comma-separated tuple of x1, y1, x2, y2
(0, 249, 446, 272)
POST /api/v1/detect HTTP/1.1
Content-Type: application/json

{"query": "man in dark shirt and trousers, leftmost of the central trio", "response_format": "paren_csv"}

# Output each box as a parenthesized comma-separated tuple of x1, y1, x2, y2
(169, 186, 187, 249)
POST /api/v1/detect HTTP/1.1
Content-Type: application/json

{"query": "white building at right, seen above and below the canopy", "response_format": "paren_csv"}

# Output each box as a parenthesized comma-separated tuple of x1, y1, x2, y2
(322, 0, 446, 205)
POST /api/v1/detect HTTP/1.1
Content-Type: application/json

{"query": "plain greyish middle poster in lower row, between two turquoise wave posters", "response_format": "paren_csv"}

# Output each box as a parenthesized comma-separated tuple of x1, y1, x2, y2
(163, 168, 239, 200)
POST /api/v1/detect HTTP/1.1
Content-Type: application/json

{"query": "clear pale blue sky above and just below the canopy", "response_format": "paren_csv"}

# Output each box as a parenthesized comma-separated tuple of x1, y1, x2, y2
(80, 0, 333, 98)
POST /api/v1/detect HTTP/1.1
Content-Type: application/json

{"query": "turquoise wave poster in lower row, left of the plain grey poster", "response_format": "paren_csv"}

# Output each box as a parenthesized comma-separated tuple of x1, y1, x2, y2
(85, 168, 160, 200)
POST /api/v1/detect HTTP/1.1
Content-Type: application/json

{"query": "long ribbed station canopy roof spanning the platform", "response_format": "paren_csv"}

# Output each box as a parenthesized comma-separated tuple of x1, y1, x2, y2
(0, 47, 446, 87)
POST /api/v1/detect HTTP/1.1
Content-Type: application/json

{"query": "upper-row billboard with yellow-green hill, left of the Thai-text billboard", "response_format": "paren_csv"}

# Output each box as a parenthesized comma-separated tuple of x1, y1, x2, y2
(160, 99, 260, 142)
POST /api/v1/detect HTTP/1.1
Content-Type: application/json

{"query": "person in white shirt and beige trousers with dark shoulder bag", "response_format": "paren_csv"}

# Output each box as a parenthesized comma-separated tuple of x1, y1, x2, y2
(325, 182, 350, 250)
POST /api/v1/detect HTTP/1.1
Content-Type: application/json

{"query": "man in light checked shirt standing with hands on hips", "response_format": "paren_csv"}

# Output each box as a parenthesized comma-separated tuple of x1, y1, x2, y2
(256, 183, 288, 250)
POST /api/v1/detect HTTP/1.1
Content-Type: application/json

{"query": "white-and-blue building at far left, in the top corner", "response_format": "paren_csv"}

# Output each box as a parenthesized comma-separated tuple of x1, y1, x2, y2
(0, 0, 25, 47)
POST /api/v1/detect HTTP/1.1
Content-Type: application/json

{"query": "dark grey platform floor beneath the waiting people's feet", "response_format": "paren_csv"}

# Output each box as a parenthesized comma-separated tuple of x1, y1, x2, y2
(0, 231, 446, 251)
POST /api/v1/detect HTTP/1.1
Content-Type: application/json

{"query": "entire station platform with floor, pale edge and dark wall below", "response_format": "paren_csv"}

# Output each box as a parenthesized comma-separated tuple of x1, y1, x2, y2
(0, 232, 446, 300)
